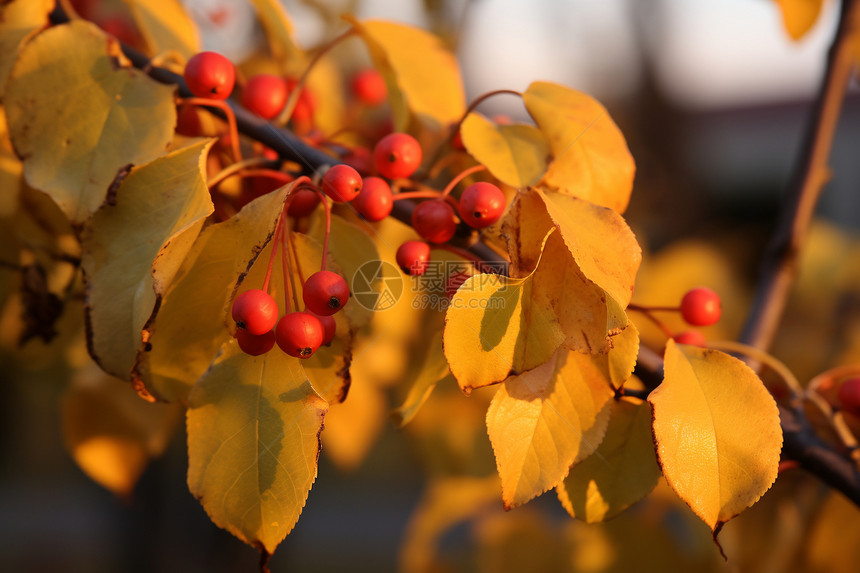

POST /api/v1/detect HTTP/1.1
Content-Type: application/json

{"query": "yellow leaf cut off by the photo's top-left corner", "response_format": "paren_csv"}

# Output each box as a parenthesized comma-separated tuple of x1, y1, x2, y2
(0, 0, 54, 96)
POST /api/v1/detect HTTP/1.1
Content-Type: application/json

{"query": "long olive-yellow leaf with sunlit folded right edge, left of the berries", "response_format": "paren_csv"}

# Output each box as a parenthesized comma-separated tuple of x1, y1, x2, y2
(81, 140, 213, 379)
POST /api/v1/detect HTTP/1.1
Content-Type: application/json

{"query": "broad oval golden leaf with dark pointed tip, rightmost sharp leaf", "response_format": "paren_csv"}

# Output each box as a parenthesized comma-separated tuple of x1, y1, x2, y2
(648, 340, 782, 533)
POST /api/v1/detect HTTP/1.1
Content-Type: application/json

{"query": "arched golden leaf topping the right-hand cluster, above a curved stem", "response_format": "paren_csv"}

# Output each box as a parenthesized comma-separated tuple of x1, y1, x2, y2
(523, 82, 636, 213)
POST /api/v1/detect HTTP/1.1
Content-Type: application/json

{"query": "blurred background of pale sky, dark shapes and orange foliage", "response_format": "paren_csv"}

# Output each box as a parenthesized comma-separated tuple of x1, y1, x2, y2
(0, 0, 860, 573)
